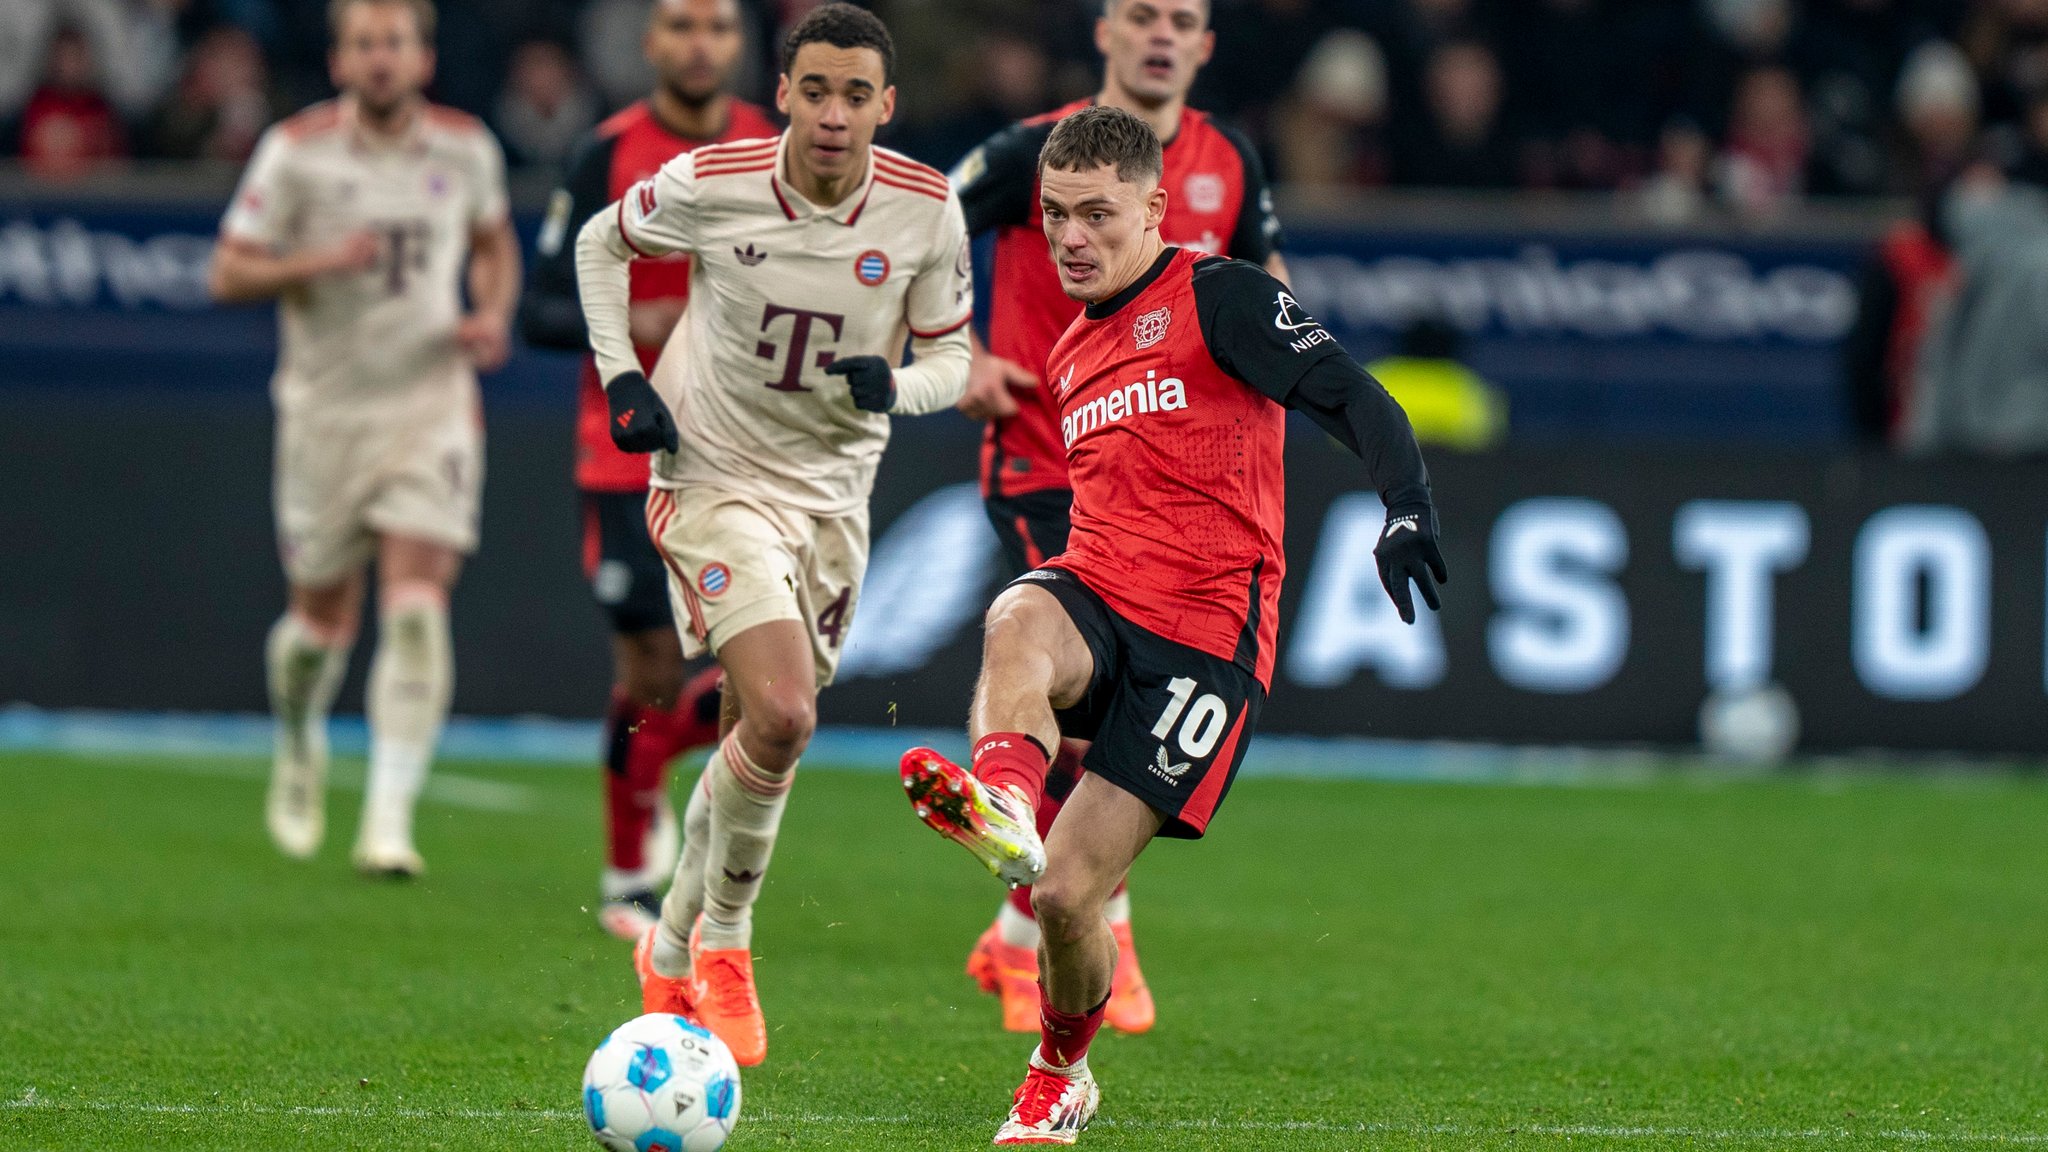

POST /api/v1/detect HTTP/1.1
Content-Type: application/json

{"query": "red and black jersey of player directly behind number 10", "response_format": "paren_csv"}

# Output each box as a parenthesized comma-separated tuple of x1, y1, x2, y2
(952, 100, 1280, 498)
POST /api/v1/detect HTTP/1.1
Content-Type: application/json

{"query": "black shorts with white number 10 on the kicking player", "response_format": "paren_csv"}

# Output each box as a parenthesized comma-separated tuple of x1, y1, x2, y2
(1016, 568, 1266, 840)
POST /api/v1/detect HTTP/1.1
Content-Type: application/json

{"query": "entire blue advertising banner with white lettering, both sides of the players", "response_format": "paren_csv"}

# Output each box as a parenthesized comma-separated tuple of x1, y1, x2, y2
(0, 203, 1864, 443)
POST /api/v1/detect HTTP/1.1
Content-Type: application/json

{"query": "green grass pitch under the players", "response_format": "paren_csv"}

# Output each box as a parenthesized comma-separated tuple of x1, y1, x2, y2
(0, 756, 2048, 1152)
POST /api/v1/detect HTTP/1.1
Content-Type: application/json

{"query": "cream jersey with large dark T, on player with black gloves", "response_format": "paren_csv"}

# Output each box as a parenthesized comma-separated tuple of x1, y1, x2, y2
(584, 133, 975, 517)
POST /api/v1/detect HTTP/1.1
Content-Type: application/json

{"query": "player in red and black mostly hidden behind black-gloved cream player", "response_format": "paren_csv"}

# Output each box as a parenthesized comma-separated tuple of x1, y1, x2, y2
(520, 0, 780, 941)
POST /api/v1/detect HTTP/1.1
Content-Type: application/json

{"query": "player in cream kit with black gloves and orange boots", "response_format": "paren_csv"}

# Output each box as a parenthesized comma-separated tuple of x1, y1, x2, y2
(575, 4, 973, 1066)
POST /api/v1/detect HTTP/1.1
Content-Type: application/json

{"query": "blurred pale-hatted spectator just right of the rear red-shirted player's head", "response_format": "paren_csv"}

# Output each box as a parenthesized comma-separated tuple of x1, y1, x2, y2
(1272, 29, 1386, 189)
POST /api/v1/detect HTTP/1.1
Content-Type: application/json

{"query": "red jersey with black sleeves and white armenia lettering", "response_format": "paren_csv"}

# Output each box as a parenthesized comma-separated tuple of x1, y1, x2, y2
(1044, 248, 1434, 687)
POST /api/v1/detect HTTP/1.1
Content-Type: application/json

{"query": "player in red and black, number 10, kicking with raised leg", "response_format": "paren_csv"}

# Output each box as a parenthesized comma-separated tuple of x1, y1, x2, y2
(903, 107, 1446, 1146)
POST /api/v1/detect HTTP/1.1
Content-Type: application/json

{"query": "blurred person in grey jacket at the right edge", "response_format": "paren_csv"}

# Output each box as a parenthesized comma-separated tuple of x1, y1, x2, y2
(1907, 166, 2048, 457)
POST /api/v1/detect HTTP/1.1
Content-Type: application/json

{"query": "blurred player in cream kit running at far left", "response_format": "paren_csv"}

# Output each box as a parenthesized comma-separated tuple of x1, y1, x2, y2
(211, 0, 520, 877)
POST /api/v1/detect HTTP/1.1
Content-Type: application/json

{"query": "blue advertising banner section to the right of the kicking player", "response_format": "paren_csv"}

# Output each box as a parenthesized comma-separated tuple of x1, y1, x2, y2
(1288, 228, 1866, 443)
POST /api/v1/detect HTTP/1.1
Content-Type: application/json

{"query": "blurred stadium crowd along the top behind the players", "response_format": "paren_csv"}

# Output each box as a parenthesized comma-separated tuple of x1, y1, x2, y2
(0, 0, 2048, 211)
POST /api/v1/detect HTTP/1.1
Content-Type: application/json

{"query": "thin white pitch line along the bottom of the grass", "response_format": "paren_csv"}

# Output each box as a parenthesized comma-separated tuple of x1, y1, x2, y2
(0, 1091, 2048, 1146)
